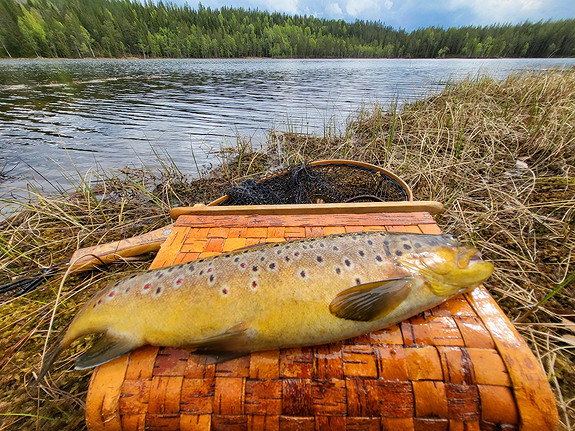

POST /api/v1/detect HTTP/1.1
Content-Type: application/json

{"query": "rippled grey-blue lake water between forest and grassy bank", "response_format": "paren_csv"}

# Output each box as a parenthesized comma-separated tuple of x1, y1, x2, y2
(0, 59, 575, 197)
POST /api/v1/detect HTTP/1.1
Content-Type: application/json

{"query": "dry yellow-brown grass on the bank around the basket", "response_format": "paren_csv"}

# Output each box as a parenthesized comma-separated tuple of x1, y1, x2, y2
(0, 69, 575, 430)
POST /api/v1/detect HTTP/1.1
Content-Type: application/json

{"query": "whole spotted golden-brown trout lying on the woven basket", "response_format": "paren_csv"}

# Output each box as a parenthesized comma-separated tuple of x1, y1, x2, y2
(39, 232, 493, 378)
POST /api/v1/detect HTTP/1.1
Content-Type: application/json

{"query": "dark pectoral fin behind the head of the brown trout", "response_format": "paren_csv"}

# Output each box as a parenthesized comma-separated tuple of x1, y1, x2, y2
(329, 277, 415, 322)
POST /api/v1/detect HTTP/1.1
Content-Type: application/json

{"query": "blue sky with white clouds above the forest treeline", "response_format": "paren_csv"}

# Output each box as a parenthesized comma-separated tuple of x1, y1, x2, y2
(181, 0, 575, 31)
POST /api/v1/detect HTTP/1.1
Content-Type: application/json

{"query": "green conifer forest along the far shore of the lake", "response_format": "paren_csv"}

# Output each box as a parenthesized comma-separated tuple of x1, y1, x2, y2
(0, 0, 575, 58)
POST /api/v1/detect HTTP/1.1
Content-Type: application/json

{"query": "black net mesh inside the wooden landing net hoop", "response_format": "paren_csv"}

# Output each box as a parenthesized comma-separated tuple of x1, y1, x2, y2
(219, 163, 409, 205)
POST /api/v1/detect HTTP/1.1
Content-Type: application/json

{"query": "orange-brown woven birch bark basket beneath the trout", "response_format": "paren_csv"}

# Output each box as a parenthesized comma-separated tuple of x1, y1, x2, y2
(86, 208, 559, 431)
